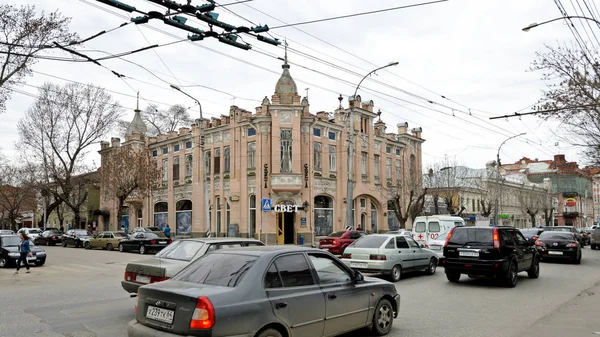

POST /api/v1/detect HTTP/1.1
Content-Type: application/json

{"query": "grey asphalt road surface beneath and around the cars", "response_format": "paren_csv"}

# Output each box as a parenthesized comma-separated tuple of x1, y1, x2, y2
(0, 247, 600, 337)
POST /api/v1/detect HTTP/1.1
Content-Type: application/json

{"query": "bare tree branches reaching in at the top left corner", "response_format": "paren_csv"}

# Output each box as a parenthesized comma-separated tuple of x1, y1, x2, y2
(0, 5, 78, 112)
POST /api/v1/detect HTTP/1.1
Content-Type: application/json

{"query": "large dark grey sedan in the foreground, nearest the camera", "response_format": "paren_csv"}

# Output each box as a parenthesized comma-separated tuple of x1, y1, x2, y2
(127, 246, 400, 337)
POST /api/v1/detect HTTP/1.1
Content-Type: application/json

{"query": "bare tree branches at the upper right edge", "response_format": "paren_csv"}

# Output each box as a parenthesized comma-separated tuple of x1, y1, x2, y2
(532, 46, 600, 165)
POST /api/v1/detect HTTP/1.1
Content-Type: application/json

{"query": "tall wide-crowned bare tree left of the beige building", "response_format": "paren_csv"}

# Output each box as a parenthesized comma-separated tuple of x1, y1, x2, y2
(17, 83, 122, 225)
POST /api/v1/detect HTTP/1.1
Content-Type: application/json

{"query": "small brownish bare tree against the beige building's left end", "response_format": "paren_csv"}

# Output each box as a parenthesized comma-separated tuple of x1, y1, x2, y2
(101, 146, 161, 227)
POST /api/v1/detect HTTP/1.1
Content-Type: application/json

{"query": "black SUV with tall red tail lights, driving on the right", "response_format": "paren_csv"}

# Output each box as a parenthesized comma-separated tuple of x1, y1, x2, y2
(444, 227, 540, 288)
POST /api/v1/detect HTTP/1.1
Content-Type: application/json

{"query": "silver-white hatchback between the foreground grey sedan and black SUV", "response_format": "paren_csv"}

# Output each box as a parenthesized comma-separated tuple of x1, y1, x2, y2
(342, 234, 438, 282)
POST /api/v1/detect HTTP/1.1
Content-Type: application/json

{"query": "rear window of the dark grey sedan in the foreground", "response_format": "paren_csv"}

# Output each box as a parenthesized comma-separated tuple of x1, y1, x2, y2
(173, 253, 256, 287)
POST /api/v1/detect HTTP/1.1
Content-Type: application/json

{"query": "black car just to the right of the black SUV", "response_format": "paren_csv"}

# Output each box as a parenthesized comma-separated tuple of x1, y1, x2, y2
(535, 231, 581, 264)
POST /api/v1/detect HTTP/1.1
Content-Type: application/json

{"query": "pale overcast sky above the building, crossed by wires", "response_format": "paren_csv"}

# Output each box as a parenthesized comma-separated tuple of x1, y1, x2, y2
(0, 0, 583, 169)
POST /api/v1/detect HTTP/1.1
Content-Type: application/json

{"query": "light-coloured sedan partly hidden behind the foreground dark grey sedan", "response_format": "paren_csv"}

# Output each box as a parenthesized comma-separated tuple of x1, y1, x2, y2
(121, 238, 264, 293)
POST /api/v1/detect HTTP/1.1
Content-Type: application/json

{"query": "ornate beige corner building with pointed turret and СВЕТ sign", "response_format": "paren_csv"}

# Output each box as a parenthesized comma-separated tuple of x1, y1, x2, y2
(100, 57, 424, 244)
